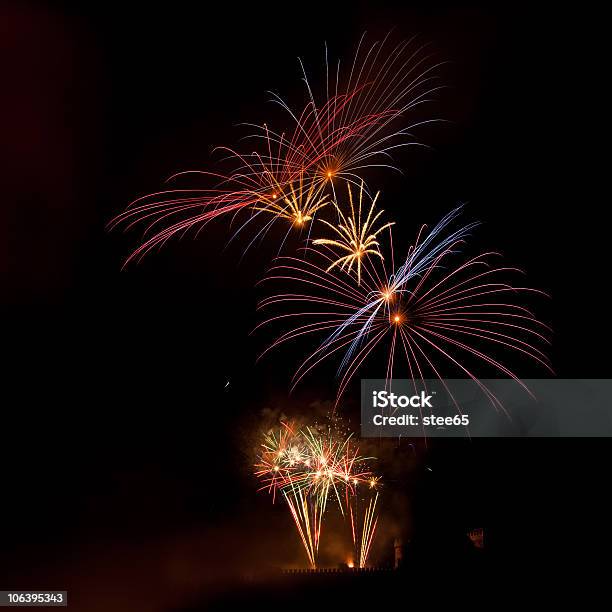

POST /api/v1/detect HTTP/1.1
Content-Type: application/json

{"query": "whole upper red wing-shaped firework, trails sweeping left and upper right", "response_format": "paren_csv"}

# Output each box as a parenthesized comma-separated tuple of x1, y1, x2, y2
(108, 35, 439, 264)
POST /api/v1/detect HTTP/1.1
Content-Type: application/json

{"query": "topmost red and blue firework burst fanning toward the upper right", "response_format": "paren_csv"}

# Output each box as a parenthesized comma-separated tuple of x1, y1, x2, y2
(264, 34, 440, 188)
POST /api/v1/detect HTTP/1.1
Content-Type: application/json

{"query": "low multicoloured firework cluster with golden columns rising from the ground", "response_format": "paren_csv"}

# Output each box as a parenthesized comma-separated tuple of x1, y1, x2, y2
(255, 422, 380, 568)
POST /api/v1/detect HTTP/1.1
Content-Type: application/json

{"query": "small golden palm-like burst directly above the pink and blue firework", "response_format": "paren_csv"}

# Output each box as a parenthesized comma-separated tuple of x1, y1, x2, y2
(314, 182, 394, 285)
